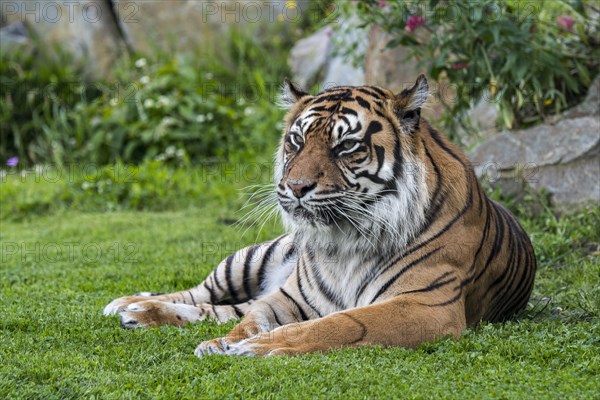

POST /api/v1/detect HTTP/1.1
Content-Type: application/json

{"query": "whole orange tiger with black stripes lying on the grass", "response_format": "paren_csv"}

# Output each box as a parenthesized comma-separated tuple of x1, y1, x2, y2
(104, 75, 536, 357)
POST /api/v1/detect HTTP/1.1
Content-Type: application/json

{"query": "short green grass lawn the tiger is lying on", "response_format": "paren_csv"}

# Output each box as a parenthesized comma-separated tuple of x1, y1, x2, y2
(0, 203, 600, 399)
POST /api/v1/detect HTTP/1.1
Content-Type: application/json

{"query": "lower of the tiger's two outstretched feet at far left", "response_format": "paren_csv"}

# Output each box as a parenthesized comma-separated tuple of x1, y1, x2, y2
(119, 300, 253, 328)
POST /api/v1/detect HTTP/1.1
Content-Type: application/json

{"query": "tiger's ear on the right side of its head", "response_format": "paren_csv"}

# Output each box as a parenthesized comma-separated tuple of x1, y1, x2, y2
(394, 74, 429, 133)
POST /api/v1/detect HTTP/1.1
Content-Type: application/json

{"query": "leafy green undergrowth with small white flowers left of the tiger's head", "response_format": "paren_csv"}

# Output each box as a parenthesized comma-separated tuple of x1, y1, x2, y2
(0, 17, 318, 166)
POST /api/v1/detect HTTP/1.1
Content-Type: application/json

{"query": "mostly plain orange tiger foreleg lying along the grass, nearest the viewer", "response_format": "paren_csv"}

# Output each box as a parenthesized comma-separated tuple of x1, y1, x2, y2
(195, 295, 466, 357)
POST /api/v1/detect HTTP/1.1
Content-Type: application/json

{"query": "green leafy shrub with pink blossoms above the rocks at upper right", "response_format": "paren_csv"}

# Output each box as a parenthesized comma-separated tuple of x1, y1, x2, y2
(350, 0, 600, 134)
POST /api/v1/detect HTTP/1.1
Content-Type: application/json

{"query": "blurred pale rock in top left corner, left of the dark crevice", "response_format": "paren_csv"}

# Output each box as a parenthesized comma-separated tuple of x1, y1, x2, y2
(2, 0, 122, 77)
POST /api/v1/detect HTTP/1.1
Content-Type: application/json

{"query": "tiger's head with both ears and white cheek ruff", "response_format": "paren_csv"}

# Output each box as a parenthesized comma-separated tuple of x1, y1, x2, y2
(275, 75, 429, 253)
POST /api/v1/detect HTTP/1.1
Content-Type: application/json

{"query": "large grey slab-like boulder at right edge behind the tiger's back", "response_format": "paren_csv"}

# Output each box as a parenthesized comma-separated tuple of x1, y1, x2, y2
(471, 78, 600, 211)
